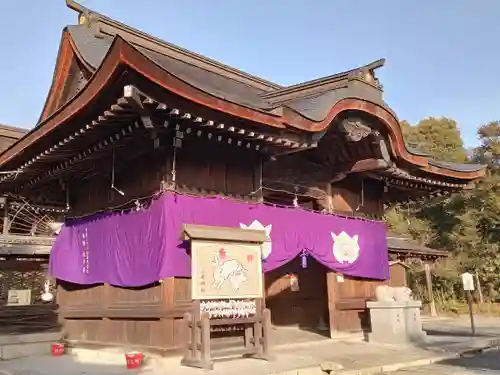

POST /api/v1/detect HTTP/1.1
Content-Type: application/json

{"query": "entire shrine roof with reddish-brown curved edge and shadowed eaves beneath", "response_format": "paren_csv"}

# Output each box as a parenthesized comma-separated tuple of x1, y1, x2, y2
(0, 0, 484, 188)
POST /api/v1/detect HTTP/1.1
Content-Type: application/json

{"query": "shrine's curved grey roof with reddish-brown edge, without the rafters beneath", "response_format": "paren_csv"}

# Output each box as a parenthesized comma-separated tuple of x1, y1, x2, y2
(0, 0, 484, 180)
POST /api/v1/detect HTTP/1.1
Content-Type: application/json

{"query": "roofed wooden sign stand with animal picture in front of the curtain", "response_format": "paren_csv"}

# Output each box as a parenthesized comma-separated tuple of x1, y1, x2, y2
(181, 225, 271, 370)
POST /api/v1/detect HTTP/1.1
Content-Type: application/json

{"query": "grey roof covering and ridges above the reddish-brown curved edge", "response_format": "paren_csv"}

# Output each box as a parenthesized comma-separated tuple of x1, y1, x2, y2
(59, 0, 485, 179)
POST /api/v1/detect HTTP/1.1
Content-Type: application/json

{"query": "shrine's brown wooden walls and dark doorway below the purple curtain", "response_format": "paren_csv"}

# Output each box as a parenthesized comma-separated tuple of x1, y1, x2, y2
(57, 258, 404, 353)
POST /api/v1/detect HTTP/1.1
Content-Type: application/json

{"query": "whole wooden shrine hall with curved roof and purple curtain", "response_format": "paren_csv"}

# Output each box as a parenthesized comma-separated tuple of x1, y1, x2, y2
(0, 0, 485, 351)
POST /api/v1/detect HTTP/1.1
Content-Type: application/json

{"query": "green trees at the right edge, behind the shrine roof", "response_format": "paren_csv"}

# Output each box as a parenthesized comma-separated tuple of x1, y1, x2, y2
(386, 118, 500, 300)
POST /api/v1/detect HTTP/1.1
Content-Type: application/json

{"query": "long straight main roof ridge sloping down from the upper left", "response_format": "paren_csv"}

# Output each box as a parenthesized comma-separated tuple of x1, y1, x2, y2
(66, 0, 283, 91)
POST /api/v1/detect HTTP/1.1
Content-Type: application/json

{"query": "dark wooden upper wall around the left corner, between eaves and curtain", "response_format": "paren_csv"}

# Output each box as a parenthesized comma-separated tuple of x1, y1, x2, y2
(70, 136, 260, 216)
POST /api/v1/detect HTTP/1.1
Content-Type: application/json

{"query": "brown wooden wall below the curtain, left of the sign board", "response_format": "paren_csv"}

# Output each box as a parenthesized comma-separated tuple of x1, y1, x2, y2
(58, 278, 191, 351)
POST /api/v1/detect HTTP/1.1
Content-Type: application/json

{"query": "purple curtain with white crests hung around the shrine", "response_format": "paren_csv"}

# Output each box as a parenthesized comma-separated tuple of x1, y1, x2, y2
(50, 193, 389, 286)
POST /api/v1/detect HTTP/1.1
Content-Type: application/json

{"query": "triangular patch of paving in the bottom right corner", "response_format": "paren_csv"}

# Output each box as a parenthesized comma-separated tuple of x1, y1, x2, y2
(391, 351, 500, 375)
